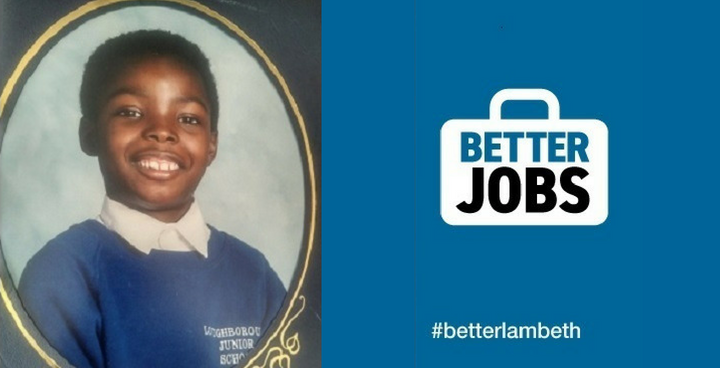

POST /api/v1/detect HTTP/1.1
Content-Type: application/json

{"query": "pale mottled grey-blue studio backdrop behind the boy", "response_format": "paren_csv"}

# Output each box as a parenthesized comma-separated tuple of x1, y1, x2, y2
(0, 7, 305, 287)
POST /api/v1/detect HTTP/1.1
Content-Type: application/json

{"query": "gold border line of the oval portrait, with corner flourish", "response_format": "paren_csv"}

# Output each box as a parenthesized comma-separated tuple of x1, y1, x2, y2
(0, 0, 317, 368)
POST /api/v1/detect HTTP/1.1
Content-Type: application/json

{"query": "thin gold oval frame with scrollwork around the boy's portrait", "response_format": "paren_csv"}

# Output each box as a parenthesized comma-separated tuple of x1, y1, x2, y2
(0, 0, 318, 368)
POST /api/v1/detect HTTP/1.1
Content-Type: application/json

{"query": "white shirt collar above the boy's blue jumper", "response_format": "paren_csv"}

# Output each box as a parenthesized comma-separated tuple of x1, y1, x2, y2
(100, 197, 210, 258)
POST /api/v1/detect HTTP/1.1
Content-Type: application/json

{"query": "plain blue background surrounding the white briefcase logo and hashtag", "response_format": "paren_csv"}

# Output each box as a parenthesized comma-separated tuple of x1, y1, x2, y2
(323, 0, 720, 368)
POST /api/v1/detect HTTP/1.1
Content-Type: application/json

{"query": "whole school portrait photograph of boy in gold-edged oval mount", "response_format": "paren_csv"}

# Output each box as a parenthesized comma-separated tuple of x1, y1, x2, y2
(0, 1, 320, 367)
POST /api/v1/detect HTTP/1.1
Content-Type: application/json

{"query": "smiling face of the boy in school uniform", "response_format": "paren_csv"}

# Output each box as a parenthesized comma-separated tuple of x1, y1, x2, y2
(88, 56, 217, 222)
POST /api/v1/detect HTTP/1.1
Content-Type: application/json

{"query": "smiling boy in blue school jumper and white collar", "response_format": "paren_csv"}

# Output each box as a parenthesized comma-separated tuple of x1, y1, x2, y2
(19, 31, 285, 367)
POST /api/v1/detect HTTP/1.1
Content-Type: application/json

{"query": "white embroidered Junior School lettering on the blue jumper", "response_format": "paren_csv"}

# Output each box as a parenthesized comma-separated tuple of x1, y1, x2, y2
(204, 326, 261, 366)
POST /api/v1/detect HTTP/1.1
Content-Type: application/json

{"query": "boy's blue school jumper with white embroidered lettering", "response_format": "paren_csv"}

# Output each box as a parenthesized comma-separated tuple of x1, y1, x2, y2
(19, 220, 285, 368)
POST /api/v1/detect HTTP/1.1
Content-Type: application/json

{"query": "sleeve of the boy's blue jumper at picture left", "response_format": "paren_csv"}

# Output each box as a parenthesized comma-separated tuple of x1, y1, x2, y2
(19, 238, 104, 368)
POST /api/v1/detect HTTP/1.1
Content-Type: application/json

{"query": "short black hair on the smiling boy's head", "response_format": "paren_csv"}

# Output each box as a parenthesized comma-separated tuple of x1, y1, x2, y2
(80, 30, 219, 132)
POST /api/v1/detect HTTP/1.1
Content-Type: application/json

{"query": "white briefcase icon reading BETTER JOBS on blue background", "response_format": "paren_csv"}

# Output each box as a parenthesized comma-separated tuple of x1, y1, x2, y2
(440, 89, 608, 225)
